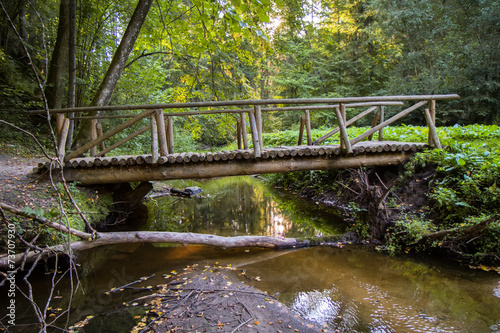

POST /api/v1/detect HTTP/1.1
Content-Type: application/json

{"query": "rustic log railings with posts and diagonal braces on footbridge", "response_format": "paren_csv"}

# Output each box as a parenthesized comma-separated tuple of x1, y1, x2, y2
(31, 94, 460, 163)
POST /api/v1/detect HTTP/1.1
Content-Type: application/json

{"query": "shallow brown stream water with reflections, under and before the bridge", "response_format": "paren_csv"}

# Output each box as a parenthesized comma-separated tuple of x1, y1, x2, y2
(0, 177, 500, 332)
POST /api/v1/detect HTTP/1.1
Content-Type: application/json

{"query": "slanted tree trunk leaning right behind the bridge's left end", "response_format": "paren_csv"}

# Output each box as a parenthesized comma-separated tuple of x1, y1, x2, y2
(72, 0, 153, 149)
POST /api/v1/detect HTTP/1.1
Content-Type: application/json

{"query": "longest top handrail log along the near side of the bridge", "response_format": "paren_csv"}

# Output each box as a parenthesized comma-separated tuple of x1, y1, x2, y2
(28, 94, 460, 115)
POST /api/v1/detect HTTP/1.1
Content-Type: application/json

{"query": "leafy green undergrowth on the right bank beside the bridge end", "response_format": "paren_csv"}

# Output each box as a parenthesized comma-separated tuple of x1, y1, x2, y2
(388, 139, 500, 263)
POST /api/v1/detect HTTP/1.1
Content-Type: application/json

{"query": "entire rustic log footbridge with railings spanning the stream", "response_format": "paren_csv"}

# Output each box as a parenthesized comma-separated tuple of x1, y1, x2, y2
(31, 94, 459, 184)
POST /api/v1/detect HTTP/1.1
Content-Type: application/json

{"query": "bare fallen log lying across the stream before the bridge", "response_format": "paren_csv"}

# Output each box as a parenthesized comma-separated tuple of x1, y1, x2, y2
(0, 231, 348, 270)
